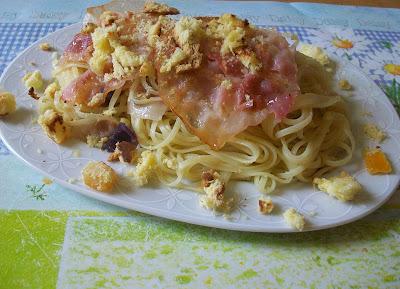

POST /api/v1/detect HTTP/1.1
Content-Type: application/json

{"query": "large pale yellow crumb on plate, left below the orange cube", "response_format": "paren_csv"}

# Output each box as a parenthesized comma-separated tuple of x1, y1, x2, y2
(313, 172, 362, 202)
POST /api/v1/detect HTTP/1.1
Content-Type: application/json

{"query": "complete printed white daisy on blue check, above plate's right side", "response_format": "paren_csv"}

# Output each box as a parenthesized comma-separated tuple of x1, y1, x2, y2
(308, 26, 372, 64)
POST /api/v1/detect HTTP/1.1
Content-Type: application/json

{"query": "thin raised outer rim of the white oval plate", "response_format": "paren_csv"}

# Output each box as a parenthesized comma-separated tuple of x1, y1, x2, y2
(0, 22, 400, 234)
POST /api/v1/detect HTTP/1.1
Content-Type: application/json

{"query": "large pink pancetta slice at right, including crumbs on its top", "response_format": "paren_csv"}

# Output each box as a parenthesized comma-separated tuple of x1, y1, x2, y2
(155, 15, 299, 149)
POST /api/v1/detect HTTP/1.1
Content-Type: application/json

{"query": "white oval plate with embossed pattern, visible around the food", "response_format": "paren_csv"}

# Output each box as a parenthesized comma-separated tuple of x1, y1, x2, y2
(0, 24, 400, 232)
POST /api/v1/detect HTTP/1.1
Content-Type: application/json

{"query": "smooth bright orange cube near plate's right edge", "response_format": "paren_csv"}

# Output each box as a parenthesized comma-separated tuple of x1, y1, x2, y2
(364, 148, 392, 175)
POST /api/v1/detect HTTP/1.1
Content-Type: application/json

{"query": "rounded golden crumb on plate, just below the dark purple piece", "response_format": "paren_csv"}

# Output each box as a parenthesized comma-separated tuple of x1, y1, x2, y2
(82, 161, 118, 192)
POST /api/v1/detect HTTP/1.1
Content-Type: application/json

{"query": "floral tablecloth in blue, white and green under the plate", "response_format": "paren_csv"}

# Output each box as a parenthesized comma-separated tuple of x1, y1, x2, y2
(0, 0, 400, 289)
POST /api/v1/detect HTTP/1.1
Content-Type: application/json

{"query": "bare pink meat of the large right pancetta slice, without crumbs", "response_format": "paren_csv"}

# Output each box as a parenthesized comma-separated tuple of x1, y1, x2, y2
(158, 21, 300, 149)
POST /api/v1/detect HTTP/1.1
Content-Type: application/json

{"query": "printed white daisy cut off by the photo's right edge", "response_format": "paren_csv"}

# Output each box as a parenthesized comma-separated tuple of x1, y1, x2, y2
(366, 50, 400, 82)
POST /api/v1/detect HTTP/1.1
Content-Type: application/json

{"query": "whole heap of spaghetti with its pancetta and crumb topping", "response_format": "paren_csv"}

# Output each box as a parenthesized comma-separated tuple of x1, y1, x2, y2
(39, 3, 355, 193)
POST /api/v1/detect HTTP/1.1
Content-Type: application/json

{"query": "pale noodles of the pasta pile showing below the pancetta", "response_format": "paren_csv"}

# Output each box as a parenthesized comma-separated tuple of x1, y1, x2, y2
(39, 2, 355, 193)
